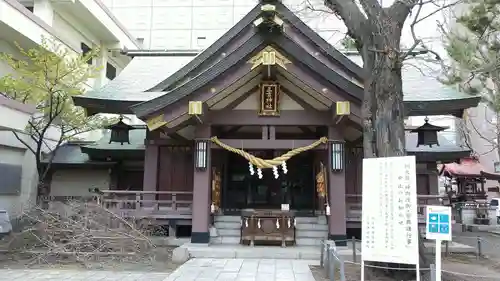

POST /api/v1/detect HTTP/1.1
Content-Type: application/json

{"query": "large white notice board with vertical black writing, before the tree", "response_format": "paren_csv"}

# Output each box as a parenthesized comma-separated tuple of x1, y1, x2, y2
(361, 156, 419, 264)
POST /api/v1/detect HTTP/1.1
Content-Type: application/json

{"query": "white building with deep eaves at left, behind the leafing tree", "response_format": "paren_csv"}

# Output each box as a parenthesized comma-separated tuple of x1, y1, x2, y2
(0, 0, 141, 216)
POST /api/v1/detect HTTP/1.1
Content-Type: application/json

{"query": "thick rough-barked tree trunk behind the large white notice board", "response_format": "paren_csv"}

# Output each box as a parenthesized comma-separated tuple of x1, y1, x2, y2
(362, 32, 430, 280)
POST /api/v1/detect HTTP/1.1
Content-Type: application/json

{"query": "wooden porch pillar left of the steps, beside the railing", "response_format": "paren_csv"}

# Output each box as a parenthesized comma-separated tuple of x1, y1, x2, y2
(191, 124, 212, 243)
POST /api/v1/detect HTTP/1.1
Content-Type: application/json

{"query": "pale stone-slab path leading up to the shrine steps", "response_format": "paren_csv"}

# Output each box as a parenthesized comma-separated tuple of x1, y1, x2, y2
(165, 258, 319, 281)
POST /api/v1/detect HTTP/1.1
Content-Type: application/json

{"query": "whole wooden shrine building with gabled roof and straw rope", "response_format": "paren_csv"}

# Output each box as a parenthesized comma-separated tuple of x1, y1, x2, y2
(47, 0, 479, 245)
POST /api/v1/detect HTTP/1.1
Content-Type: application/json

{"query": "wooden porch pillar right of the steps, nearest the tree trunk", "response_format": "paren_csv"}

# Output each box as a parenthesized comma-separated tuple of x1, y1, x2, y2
(327, 127, 347, 246)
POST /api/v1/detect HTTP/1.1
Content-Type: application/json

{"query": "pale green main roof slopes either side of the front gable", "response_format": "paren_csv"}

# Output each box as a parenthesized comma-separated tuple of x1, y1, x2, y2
(74, 52, 480, 116)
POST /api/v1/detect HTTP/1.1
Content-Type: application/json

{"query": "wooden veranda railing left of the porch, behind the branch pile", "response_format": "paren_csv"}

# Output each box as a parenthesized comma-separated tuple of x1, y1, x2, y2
(97, 190, 193, 219)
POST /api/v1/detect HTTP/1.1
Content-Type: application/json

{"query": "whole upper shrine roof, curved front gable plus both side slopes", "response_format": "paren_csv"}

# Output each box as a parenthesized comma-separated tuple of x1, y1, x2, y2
(73, 1, 480, 117)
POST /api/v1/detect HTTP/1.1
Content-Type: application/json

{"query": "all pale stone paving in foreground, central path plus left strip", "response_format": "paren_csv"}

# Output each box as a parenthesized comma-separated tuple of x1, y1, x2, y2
(0, 258, 319, 281)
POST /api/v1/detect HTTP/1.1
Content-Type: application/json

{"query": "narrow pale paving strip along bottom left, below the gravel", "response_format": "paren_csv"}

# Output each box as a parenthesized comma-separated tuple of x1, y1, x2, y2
(0, 269, 169, 281)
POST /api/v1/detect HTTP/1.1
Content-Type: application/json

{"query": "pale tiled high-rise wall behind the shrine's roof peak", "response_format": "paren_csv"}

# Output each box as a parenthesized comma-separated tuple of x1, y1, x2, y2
(103, 0, 344, 50)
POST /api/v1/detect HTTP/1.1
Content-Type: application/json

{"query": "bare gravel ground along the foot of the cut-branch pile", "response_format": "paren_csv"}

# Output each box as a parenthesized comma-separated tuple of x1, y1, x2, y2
(0, 247, 179, 272)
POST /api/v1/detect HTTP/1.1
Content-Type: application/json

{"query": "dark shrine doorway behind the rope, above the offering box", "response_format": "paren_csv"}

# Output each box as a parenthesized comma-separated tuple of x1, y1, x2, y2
(221, 150, 316, 215)
